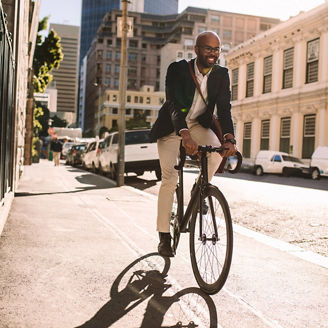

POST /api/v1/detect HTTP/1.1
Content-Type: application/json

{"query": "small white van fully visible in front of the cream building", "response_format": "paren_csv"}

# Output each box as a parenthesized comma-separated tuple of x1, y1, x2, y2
(254, 150, 309, 176)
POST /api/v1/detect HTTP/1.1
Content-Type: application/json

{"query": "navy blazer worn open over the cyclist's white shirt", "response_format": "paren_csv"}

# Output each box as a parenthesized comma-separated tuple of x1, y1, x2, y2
(150, 59, 233, 141)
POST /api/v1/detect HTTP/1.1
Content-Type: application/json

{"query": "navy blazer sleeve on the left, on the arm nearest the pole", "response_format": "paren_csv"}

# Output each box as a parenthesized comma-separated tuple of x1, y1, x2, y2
(165, 62, 188, 134)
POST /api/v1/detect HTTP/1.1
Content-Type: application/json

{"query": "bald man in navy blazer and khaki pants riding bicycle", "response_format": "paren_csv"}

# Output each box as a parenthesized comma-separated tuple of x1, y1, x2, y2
(151, 31, 236, 257)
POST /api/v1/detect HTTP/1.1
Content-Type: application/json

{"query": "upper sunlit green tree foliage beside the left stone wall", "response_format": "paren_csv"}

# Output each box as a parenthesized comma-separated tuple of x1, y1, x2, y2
(33, 17, 64, 92)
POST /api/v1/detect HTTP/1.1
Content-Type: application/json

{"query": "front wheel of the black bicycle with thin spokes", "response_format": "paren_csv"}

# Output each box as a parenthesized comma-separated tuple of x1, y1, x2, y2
(190, 185, 233, 294)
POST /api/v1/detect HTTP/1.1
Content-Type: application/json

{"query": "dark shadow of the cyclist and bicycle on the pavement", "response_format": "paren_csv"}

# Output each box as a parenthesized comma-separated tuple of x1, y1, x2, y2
(76, 253, 217, 328)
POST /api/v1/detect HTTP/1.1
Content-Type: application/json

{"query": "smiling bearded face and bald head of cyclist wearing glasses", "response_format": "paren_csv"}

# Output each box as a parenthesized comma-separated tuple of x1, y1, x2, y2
(195, 35, 220, 68)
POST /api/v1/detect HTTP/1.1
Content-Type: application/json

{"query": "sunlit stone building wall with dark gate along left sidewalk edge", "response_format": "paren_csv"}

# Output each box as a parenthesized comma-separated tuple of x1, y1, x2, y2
(0, 0, 40, 234)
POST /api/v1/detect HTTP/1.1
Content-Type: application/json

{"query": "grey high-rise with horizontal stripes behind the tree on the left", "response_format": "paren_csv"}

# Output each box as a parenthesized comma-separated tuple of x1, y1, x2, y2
(50, 24, 80, 124)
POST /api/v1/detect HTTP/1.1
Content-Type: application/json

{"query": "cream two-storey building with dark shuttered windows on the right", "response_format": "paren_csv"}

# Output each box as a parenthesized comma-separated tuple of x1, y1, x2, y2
(226, 2, 328, 159)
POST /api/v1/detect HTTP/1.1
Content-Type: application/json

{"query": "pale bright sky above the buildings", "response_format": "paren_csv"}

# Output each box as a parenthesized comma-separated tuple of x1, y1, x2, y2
(40, 0, 327, 25)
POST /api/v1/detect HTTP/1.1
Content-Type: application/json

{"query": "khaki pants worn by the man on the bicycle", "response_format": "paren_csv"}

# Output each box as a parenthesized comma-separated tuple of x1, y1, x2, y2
(157, 123, 222, 232)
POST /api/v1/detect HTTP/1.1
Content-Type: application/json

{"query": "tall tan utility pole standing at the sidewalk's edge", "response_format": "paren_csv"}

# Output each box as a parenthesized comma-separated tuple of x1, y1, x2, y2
(117, 0, 129, 187)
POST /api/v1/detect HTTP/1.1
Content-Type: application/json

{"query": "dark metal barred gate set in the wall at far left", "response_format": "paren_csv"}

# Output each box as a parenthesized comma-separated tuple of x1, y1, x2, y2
(0, 2, 15, 205)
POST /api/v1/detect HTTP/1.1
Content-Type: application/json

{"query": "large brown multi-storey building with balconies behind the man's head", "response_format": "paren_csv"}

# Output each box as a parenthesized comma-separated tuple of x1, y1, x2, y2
(85, 7, 280, 130)
